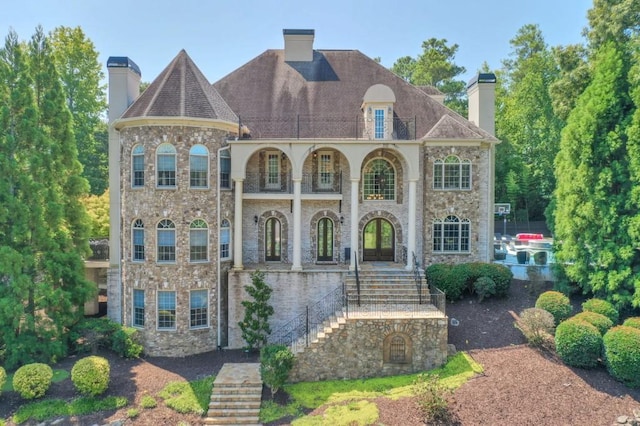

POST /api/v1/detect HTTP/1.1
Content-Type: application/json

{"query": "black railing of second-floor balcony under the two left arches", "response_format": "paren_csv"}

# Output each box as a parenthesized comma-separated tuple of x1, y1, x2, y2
(244, 172, 342, 194)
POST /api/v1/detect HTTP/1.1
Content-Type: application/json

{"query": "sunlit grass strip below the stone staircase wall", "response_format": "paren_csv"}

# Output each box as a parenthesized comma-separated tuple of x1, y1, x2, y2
(260, 352, 483, 425)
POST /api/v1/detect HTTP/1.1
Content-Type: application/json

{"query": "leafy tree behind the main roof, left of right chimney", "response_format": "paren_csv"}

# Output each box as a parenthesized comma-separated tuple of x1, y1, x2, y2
(391, 38, 467, 117)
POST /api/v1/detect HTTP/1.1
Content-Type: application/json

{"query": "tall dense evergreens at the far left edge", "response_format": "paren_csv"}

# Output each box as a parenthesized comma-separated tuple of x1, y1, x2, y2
(0, 28, 93, 368)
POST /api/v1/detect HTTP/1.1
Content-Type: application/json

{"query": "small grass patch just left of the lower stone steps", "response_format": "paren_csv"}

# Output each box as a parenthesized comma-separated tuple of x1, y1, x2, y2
(158, 376, 215, 415)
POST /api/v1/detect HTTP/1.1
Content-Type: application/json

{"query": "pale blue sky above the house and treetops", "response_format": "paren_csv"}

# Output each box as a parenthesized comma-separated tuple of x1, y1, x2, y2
(0, 0, 592, 83)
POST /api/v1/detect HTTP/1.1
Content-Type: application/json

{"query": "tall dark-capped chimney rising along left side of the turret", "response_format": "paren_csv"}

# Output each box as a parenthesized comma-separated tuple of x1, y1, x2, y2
(107, 56, 141, 324)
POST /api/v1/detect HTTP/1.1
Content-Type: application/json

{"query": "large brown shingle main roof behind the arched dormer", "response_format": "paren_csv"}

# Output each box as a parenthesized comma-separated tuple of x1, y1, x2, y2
(213, 50, 496, 140)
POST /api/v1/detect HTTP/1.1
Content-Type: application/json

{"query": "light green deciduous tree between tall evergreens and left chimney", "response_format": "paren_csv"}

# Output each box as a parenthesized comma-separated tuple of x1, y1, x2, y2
(50, 27, 109, 195)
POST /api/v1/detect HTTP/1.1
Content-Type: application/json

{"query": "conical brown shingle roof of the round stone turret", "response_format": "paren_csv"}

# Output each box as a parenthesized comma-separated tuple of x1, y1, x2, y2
(122, 50, 238, 123)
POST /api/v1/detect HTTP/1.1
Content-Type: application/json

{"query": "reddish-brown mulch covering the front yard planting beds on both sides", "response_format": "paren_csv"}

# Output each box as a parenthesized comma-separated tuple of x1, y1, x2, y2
(0, 281, 640, 426)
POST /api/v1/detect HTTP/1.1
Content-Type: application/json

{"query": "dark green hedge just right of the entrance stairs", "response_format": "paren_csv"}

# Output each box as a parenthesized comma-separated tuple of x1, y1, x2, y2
(425, 262, 513, 300)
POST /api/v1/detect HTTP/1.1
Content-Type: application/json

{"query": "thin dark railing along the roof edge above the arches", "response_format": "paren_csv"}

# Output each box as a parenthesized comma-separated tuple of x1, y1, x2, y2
(238, 115, 417, 140)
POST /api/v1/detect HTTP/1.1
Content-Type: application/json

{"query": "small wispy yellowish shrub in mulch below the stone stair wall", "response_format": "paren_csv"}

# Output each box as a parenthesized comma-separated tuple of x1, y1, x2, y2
(413, 374, 451, 424)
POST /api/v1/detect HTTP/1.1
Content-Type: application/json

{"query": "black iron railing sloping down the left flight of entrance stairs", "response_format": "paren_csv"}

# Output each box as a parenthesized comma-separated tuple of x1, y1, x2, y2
(268, 286, 344, 353)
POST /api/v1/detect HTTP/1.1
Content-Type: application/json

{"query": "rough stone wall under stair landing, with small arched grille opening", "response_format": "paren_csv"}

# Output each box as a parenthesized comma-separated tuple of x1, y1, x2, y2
(289, 317, 447, 382)
